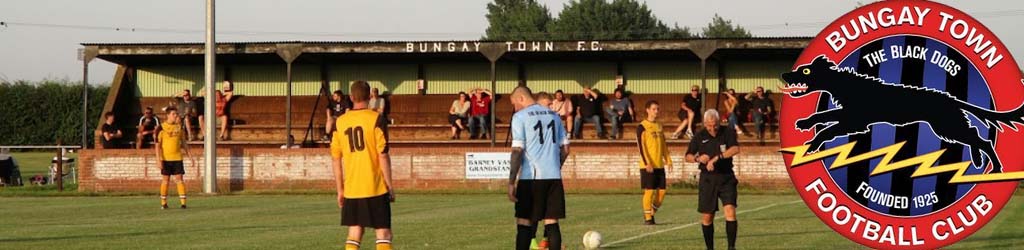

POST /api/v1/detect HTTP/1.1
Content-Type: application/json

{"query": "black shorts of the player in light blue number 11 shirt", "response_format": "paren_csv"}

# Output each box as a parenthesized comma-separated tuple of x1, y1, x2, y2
(515, 179, 565, 221)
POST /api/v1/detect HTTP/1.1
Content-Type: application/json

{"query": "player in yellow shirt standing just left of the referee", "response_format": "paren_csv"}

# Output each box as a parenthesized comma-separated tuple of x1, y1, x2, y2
(637, 100, 672, 224)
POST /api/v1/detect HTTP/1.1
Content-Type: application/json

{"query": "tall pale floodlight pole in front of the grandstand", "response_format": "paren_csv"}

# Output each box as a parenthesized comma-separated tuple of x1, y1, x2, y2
(203, 0, 218, 194)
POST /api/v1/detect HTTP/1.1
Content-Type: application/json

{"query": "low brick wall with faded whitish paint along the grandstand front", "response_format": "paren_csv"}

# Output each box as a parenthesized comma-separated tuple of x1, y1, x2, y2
(93, 146, 788, 181)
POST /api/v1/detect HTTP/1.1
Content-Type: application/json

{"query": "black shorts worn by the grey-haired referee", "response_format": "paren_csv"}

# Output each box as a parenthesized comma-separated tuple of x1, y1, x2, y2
(697, 173, 738, 213)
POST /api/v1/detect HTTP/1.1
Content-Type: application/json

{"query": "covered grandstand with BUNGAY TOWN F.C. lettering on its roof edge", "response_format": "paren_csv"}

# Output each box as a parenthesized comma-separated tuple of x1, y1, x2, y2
(82, 38, 809, 190)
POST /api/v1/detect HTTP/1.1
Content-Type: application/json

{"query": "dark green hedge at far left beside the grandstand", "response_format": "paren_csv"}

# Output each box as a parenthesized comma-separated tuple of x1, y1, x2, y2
(0, 80, 111, 145)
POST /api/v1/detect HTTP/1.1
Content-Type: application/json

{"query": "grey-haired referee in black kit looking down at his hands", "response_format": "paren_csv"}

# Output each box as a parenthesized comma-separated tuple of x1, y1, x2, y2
(686, 110, 739, 249)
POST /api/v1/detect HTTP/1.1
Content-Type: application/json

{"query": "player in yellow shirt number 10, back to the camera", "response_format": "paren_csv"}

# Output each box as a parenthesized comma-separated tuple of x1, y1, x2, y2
(331, 81, 394, 250)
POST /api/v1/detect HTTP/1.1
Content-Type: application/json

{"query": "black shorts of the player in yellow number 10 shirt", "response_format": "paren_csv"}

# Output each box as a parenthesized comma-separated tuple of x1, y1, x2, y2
(341, 194, 391, 228)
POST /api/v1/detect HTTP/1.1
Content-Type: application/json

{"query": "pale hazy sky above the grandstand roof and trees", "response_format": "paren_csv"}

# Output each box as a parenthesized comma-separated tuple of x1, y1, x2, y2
(0, 0, 1024, 83)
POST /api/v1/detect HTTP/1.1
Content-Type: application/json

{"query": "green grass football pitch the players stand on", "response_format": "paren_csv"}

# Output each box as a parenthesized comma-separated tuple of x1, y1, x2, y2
(0, 192, 1024, 249)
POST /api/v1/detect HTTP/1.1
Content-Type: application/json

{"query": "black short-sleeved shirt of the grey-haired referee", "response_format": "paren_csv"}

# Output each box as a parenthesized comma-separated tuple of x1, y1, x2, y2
(686, 126, 739, 174)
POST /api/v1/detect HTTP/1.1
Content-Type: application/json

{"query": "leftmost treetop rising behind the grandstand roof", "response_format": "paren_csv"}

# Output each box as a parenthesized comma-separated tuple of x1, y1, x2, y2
(484, 0, 551, 40)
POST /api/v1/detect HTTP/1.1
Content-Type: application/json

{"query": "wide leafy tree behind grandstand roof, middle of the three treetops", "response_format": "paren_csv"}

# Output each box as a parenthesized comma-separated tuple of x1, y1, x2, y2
(548, 0, 692, 40)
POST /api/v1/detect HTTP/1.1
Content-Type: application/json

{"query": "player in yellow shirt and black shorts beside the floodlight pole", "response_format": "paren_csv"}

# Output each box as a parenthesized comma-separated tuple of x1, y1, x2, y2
(154, 107, 196, 209)
